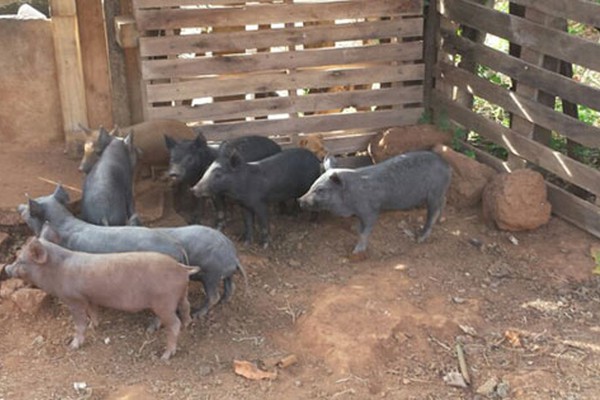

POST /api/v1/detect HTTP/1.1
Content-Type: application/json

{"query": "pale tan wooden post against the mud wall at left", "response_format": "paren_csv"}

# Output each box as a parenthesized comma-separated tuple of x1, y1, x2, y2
(50, 0, 88, 156)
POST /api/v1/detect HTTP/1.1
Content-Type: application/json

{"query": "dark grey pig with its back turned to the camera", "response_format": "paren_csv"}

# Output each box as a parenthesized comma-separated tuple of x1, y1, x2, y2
(81, 130, 139, 225)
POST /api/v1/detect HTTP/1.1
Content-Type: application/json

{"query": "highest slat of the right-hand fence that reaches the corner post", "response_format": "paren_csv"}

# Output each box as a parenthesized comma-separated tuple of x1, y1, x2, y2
(437, 0, 600, 71)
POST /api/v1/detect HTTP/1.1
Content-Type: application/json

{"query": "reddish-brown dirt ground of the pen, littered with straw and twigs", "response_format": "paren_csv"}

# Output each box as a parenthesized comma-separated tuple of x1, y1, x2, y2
(0, 142, 600, 400)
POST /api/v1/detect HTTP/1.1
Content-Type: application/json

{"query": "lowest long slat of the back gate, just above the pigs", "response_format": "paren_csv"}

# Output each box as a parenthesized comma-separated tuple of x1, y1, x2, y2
(182, 108, 423, 140)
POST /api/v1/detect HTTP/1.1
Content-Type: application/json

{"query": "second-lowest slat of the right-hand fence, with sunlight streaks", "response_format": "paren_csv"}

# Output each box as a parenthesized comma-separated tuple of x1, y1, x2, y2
(433, 91, 600, 194)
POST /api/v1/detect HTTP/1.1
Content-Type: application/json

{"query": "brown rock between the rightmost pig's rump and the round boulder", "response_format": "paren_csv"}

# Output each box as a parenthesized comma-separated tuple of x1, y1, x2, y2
(433, 145, 497, 208)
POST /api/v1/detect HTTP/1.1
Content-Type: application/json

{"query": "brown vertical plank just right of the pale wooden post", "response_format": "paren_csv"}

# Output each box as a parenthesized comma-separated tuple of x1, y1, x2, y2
(76, 0, 113, 128)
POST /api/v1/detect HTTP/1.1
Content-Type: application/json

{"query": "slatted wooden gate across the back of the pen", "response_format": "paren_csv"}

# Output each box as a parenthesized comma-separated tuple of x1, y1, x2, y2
(133, 0, 424, 153)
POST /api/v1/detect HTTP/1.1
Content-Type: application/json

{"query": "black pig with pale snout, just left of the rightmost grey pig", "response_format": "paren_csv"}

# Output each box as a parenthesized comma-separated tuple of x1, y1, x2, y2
(192, 148, 321, 247)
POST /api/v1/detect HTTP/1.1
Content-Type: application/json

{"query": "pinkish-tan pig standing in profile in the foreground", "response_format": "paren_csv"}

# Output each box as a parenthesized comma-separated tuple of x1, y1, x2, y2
(6, 237, 200, 360)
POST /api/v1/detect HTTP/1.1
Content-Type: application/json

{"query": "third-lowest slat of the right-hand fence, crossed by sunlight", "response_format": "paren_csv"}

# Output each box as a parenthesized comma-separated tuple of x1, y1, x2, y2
(438, 63, 600, 147)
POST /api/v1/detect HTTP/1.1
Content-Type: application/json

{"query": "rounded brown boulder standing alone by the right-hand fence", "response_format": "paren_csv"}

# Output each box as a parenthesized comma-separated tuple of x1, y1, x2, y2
(483, 169, 552, 231)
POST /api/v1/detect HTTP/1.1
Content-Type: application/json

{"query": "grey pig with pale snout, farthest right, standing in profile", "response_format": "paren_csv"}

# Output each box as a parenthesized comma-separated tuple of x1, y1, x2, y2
(299, 151, 451, 257)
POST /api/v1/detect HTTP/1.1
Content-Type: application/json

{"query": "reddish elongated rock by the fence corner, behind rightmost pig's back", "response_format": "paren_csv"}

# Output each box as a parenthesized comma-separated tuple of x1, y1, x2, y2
(368, 124, 452, 164)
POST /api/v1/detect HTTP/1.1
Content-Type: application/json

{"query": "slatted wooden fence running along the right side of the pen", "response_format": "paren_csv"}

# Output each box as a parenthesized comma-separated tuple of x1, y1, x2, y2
(425, 0, 600, 236)
